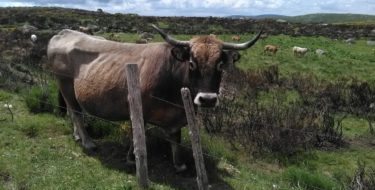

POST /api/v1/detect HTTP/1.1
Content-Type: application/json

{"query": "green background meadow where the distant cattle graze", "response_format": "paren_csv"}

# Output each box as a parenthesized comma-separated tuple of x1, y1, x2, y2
(101, 33, 375, 83)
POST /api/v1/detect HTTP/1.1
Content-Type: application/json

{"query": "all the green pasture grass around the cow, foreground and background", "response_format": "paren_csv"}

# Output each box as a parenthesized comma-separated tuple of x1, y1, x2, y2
(0, 33, 375, 190)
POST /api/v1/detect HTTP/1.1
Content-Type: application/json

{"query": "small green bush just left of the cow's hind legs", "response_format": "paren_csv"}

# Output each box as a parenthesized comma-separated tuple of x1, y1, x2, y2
(25, 85, 57, 113)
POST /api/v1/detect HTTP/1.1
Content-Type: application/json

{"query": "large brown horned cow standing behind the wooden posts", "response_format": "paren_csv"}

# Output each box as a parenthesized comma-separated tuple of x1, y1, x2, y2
(48, 25, 261, 171)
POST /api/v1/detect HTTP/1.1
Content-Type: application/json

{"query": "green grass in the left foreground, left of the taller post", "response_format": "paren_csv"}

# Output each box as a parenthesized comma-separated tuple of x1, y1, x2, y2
(0, 90, 169, 189)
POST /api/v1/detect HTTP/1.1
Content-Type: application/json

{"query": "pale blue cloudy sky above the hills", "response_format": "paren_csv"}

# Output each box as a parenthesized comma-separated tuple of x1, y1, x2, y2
(0, 0, 375, 16)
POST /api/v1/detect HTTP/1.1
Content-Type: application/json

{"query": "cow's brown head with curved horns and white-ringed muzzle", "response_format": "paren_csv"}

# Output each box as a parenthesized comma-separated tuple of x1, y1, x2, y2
(152, 25, 261, 107)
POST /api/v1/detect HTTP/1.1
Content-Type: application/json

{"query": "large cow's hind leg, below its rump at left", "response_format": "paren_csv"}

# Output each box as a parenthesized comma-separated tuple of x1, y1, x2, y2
(58, 79, 96, 150)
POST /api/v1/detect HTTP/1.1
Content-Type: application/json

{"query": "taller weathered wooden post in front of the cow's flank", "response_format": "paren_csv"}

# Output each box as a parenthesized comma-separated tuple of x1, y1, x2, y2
(126, 64, 148, 188)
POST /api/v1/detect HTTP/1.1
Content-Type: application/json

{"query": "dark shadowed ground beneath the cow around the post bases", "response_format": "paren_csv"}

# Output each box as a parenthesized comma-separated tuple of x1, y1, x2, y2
(82, 134, 233, 190)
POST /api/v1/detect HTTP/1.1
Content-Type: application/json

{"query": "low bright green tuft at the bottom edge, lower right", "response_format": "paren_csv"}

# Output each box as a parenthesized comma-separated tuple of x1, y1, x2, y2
(283, 167, 340, 190)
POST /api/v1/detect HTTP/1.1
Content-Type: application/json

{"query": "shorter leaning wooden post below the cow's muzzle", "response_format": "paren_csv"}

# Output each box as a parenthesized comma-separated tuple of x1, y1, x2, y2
(181, 88, 208, 190)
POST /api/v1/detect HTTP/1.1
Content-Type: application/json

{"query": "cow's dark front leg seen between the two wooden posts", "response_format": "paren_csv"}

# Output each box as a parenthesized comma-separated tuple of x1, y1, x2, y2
(170, 129, 186, 172)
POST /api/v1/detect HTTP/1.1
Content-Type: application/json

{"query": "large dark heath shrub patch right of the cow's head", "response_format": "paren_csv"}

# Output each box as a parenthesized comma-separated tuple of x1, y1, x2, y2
(201, 67, 345, 157)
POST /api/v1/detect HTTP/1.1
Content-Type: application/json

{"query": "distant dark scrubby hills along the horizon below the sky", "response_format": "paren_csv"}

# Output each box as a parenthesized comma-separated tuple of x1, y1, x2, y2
(0, 7, 375, 39)
